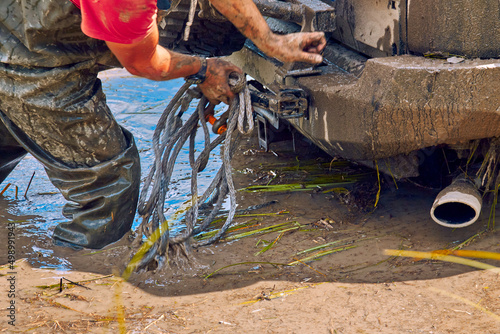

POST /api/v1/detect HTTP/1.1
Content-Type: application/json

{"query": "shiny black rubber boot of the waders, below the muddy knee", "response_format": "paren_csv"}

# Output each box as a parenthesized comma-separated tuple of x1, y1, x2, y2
(47, 130, 140, 248)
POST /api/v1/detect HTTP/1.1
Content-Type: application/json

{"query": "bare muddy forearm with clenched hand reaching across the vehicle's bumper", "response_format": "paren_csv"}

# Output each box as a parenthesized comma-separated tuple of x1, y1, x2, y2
(209, 0, 326, 63)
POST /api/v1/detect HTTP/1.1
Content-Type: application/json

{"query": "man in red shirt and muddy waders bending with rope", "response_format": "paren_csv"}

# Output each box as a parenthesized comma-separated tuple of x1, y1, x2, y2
(0, 0, 326, 248)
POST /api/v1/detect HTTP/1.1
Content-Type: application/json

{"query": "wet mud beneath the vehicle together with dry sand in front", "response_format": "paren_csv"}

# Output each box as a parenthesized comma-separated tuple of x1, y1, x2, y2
(0, 130, 500, 334)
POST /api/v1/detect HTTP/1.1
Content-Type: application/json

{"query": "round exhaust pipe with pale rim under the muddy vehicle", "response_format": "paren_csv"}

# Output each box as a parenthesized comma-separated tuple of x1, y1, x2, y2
(431, 177, 483, 228)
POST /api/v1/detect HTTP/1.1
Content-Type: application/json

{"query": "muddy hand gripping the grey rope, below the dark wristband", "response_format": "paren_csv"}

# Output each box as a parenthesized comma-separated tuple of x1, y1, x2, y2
(199, 58, 243, 104)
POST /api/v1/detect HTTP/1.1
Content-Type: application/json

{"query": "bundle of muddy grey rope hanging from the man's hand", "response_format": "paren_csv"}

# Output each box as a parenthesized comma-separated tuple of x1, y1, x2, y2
(133, 73, 254, 270)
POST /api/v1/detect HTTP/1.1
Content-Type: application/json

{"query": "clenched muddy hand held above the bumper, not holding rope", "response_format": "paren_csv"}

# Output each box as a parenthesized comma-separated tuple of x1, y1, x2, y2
(259, 32, 326, 64)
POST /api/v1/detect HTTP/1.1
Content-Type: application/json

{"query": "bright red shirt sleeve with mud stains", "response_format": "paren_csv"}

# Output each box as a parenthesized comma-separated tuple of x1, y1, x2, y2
(71, 0, 157, 44)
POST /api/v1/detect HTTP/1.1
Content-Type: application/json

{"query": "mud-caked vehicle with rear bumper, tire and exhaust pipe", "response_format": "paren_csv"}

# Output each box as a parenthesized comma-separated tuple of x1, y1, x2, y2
(160, 0, 500, 227)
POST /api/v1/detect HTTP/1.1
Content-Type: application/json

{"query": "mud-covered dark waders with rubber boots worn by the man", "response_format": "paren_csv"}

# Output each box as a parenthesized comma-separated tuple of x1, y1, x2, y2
(0, 0, 140, 248)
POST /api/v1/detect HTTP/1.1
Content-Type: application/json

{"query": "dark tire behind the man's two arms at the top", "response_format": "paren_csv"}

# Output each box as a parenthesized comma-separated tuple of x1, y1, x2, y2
(158, 0, 246, 57)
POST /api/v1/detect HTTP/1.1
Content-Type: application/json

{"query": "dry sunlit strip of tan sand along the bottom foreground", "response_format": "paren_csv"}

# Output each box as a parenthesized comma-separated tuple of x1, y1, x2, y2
(2, 263, 500, 333)
